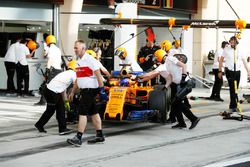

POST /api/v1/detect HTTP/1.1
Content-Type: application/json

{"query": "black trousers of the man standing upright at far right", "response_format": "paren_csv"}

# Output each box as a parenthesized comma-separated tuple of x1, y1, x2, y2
(225, 68, 240, 109)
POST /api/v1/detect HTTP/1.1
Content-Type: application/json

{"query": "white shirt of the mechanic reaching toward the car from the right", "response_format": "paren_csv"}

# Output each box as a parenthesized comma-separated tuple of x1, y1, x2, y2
(164, 56, 182, 84)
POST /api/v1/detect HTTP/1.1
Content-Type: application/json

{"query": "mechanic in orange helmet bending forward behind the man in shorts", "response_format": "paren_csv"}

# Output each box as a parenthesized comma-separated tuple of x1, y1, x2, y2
(35, 60, 77, 135)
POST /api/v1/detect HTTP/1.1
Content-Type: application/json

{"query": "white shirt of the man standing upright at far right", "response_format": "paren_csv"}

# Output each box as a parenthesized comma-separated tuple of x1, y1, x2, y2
(222, 46, 245, 71)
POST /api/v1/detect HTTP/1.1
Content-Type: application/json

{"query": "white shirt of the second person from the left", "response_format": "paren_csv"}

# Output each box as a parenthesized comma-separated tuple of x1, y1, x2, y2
(15, 43, 30, 66)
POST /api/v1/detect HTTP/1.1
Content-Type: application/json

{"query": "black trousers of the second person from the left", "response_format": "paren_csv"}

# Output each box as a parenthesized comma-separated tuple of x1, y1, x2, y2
(16, 63, 30, 95)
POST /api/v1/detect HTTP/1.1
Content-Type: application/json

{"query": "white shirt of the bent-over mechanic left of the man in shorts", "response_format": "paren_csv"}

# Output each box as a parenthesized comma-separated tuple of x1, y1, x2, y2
(47, 70, 76, 93)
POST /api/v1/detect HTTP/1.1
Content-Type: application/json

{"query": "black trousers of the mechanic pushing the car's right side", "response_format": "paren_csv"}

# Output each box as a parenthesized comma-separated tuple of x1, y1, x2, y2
(171, 83, 197, 125)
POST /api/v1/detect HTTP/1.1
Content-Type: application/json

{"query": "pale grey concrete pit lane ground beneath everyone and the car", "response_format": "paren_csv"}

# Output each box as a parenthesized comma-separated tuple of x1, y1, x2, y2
(0, 88, 250, 167)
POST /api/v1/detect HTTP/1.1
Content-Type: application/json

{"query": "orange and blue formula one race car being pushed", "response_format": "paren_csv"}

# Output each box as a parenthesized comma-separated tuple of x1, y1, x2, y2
(96, 64, 170, 123)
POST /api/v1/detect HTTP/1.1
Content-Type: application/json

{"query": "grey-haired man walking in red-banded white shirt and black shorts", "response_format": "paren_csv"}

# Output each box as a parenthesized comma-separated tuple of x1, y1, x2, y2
(67, 40, 108, 146)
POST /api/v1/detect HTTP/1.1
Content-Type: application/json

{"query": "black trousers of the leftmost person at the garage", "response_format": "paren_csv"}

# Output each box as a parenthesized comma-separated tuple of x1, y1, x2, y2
(4, 61, 16, 92)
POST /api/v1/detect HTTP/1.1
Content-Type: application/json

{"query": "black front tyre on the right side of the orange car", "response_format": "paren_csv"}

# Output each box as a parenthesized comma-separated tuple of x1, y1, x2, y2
(148, 89, 170, 123)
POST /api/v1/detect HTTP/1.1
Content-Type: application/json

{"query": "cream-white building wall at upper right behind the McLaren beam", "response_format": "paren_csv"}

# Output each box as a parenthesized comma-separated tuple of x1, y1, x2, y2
(193, 0, 250, 86)
